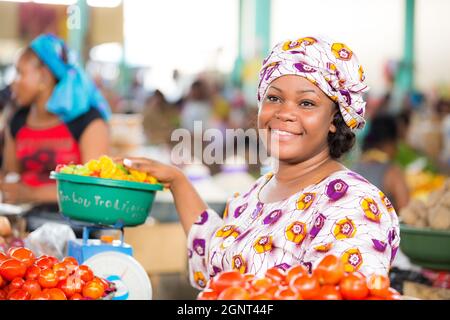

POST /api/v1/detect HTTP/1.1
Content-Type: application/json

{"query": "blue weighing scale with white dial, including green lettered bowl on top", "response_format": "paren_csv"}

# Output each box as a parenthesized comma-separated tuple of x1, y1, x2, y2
(50, 172, 163, 300)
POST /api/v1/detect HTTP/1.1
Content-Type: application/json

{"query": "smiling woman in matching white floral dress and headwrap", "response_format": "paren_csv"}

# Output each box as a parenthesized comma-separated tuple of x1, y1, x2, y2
(120, 37, 399, 288)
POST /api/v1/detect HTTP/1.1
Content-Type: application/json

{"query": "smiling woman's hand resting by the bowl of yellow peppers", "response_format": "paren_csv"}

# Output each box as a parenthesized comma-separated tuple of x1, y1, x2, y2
(122, 157, 185, 188)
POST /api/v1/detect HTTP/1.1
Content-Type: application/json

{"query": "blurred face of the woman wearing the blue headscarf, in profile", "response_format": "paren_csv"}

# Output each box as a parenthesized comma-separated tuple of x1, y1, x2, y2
(12, 54, 45, 106)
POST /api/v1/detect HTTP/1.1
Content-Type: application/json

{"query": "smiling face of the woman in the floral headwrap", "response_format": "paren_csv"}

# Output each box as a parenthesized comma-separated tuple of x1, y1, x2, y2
(258, 75, 337, 163)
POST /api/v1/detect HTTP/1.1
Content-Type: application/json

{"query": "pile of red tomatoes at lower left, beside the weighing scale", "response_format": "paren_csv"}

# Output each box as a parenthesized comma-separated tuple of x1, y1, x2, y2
(0, 247, 114, 300)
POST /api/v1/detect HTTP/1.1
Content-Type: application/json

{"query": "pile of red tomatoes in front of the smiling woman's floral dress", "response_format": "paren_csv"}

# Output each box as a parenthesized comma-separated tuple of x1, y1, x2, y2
(197, 255, 401, 300)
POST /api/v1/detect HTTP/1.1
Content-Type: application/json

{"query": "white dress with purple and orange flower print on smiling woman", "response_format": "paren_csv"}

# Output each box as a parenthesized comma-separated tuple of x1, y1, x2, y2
(188, 170, 400, 289)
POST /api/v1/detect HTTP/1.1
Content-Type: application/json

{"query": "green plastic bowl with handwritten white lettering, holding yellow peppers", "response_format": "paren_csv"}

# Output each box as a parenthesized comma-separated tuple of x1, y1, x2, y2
(50, 172, 163, 226)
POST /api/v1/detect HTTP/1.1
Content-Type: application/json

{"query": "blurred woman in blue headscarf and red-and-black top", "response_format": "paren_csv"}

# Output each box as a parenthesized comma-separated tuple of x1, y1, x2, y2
(1, 35, 110, 232)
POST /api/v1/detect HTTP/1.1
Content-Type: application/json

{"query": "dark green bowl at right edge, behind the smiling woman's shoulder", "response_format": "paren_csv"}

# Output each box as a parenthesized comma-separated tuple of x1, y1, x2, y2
(400, 224, 450, 270)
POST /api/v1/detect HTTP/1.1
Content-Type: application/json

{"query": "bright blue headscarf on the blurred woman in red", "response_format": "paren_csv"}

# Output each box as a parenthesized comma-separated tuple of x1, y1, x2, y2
(30, 34, 111, 123)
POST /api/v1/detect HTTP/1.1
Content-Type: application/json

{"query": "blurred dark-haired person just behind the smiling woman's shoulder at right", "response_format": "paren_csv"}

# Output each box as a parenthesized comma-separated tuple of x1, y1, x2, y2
(353, 114, 409, 211)
